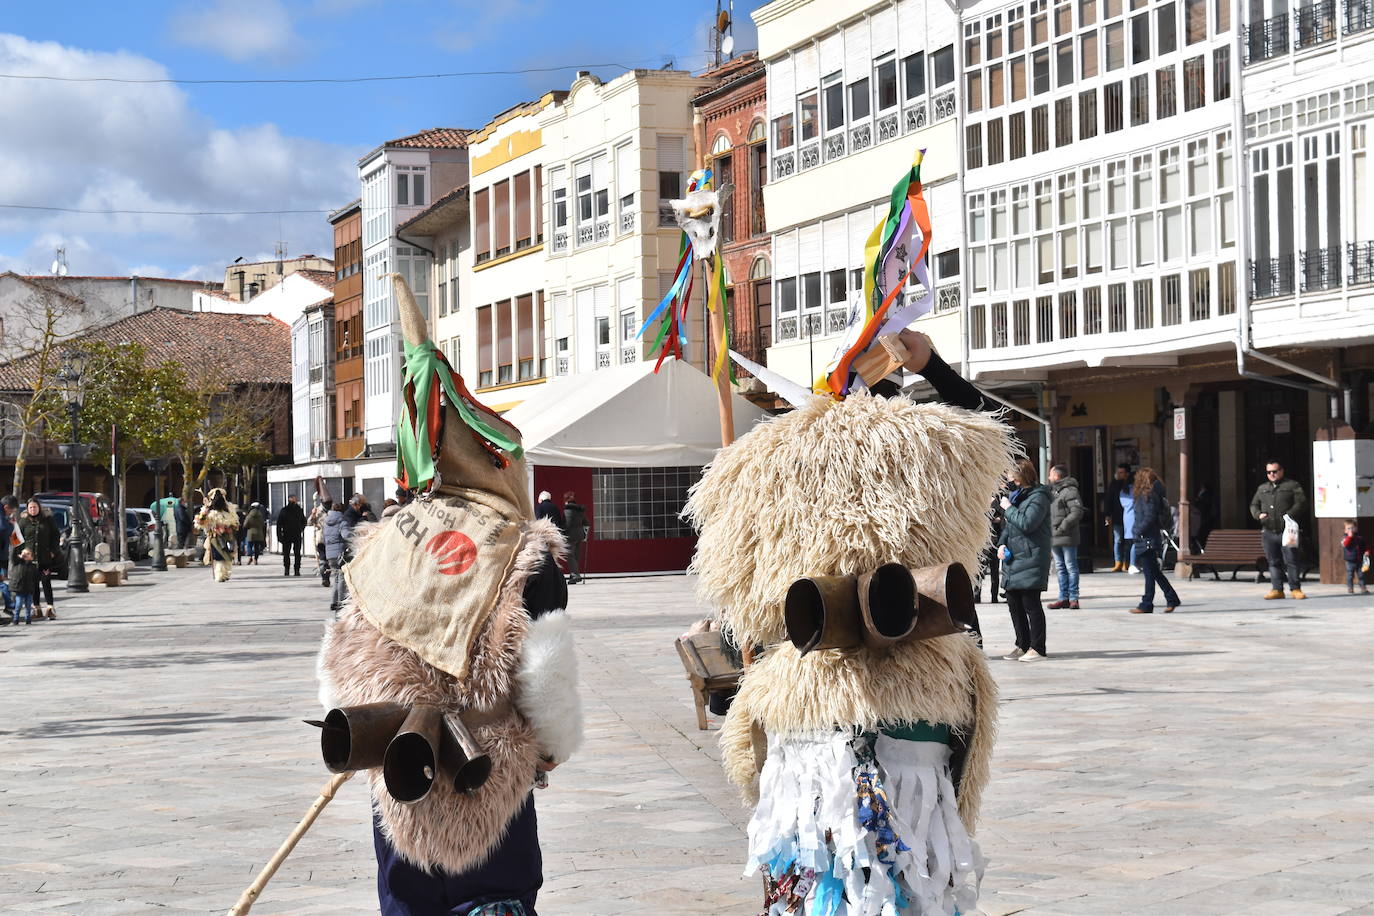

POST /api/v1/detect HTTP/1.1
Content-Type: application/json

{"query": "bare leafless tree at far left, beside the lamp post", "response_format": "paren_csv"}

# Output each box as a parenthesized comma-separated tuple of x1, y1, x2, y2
(0, 280, 82, 494)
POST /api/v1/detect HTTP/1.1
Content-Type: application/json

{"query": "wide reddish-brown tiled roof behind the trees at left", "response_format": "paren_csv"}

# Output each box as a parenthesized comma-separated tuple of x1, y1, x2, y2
(0, 308, 291, 391)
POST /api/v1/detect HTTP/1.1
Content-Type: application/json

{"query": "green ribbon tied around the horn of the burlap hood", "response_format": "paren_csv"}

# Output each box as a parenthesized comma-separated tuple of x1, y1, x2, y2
(396, 341, 525, 489)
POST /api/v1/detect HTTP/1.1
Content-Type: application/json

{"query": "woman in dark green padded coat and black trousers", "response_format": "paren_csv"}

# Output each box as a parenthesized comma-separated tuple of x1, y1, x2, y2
(998, 459, 1051, 662)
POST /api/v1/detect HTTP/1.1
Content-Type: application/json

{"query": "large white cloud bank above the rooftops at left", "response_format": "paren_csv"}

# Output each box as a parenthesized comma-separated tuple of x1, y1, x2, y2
(0, 34, 363, 279)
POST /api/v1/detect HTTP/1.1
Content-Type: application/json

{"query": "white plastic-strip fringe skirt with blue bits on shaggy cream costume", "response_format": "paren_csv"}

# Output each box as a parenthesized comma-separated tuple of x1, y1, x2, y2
(745, 732, 984, 916)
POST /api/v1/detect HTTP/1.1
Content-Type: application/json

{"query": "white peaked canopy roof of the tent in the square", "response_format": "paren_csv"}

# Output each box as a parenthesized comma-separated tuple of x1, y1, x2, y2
(504, 358, 764, 467)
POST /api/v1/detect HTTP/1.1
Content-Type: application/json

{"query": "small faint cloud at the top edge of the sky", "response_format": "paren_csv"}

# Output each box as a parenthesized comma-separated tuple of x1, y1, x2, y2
(168, 0, 304, 62)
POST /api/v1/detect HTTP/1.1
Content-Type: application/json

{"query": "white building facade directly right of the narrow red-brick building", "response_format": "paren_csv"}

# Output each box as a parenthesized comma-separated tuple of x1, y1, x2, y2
(754, 0, 963, 385)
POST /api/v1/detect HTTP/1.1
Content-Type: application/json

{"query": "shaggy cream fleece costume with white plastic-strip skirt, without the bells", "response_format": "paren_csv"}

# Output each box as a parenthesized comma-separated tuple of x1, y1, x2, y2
(686, 390, 1015, 916)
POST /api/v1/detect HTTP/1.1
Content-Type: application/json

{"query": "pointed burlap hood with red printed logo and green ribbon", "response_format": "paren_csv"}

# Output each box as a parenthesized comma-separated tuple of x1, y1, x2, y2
(345, 275, 533, 678)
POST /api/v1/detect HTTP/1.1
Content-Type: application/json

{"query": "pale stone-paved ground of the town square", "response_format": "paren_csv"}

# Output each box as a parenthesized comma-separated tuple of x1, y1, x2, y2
(0, 554, 1374, 916)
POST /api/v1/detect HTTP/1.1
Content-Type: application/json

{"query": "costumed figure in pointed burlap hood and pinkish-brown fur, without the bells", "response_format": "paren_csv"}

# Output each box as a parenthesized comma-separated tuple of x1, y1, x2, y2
(317, 277, 581, 916)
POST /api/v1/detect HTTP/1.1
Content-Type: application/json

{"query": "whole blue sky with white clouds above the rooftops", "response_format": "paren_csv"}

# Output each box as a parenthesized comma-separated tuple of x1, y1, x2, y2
(0, 0, 763, 279)
